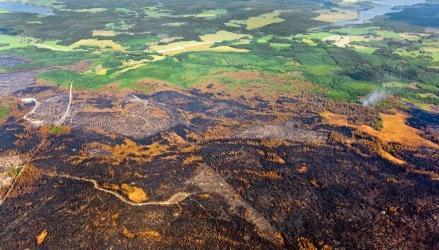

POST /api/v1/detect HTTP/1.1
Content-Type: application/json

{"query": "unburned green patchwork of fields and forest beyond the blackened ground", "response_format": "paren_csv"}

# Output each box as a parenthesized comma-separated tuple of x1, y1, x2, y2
(0, 1, 439, 107)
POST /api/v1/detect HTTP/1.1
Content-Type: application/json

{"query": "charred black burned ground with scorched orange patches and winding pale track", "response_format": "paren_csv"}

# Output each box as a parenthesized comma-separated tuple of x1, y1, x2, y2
(0, 83, 439, 249)
